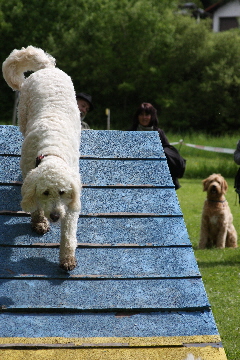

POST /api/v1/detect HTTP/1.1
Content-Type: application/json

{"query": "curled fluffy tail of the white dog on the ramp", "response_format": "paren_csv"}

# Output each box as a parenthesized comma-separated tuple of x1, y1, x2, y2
(2, 45, 56, 90)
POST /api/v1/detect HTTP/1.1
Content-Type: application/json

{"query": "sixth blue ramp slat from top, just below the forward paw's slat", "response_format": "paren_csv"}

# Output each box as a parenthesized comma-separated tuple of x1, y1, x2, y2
(0, 278, 209, 311)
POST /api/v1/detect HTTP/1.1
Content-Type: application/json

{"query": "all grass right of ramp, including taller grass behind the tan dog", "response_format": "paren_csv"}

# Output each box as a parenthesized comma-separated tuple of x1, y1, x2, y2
(172, 132, 240, 360)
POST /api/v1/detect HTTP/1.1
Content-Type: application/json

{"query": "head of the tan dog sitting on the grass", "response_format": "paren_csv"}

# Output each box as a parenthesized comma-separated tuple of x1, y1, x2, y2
(202, 174, 228, 199)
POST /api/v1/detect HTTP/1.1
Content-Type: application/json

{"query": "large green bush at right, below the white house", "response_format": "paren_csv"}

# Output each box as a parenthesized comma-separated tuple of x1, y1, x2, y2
(157, 17, 240, 134)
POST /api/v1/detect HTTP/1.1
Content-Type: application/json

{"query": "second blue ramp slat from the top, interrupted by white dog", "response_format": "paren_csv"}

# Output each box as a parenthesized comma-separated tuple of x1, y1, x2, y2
(0, 156, 174, 187)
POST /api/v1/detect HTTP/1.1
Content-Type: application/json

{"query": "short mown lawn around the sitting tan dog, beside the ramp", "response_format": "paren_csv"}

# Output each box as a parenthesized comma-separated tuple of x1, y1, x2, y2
(177, 178, 240, 360)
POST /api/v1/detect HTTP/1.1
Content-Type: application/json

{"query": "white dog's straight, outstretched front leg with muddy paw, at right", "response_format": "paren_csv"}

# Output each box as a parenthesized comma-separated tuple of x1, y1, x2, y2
(60, 211, 79, 271)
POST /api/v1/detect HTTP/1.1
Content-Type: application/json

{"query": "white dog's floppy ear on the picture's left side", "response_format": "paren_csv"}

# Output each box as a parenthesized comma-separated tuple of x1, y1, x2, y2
(21, 169, 37, 213)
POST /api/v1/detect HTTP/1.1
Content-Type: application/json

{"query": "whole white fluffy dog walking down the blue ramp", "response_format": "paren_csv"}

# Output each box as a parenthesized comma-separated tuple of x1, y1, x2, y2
(3, 46, 81, 271)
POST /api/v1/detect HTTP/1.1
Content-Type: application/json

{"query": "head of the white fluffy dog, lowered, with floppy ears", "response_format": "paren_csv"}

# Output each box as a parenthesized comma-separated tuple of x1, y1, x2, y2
(21, 164, 80, 222)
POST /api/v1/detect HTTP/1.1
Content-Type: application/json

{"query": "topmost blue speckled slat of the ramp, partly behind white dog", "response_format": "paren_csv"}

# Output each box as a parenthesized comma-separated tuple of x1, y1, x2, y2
(0, 125, 165, 159)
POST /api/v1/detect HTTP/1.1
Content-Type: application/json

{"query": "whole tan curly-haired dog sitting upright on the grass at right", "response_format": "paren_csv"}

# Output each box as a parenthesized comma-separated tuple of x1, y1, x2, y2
(199, 174, 237, 249)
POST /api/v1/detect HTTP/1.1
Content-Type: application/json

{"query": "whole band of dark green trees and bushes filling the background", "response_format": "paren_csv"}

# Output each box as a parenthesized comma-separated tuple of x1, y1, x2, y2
(0, 0, 240, 133)
